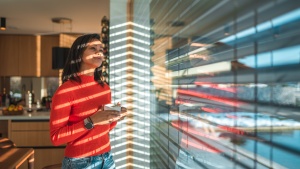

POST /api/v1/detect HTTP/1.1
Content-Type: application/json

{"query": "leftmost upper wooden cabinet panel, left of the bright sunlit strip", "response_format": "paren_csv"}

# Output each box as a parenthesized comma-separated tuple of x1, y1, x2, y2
(0, 35, 38, 76)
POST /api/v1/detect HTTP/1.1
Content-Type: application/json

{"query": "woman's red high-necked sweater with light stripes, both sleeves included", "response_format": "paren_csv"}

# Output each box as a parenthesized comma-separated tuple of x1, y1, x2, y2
(50, 75, 116, 157)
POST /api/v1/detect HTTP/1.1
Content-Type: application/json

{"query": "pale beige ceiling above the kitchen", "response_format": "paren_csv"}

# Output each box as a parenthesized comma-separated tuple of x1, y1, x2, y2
(0, 0, 110, 35)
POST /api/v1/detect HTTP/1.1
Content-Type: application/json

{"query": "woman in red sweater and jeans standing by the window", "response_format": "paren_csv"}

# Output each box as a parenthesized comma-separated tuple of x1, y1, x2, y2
(50, 34, 126, 169)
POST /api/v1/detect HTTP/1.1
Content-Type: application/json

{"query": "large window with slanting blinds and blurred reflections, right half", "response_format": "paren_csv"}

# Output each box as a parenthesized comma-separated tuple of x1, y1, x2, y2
(151, 0, 300, 169)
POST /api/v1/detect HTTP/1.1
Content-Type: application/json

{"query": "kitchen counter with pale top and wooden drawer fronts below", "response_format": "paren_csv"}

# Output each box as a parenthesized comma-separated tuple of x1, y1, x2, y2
(0, 110, 65, 169)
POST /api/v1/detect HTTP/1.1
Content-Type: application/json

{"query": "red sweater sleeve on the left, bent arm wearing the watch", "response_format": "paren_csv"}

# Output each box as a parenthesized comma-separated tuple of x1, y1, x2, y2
(50, 89, 87, 145)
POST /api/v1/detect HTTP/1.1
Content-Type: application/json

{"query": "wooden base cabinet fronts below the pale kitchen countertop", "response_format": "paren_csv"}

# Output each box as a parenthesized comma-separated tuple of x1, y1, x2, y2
(0, 120, 65, 168)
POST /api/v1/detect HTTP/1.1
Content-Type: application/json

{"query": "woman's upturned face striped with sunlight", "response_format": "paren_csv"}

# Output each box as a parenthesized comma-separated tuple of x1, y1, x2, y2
(80, 39, 104, 72)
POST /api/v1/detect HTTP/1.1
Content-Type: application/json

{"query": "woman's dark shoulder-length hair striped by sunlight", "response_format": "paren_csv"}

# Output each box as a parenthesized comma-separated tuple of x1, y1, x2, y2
(61, 33, 104, 86)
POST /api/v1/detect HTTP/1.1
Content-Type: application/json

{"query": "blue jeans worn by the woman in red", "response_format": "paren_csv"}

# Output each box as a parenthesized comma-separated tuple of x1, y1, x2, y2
(62, 152, 116, 169)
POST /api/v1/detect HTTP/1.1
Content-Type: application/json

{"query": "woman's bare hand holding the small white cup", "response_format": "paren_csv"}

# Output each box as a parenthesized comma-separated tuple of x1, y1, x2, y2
(90, 110, 122, 125)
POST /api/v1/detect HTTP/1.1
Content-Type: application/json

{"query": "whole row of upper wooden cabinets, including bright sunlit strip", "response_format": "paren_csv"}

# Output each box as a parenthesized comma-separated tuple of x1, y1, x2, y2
(0, 34, 81, 77)
